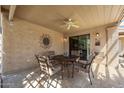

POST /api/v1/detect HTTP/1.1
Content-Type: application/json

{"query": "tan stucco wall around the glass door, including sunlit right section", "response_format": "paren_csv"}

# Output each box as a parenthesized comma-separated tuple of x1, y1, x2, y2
(65, 26, 119, 66)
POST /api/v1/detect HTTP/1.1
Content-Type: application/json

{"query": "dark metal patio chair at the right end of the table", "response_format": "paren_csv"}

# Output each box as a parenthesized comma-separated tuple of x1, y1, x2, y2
(76, 54, 95, 85)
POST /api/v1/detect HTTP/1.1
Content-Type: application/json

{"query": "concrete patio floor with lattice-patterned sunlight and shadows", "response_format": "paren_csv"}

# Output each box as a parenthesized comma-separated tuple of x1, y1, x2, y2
(3, 63, 124, 88)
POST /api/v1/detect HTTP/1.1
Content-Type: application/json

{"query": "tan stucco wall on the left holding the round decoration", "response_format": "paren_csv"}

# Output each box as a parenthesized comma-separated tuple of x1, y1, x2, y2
(3, 16, 63, 73)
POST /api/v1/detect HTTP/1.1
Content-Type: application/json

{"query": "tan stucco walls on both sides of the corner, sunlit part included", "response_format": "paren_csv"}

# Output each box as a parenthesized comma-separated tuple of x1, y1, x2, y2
(3, 13, 119, 73)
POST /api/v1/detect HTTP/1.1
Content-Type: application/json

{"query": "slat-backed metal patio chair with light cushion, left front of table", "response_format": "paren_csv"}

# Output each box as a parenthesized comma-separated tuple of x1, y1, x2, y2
(35, 55, 61, 77)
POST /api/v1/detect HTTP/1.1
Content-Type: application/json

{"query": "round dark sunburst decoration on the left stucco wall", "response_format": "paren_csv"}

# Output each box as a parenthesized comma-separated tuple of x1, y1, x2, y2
(40, 34, 52, 49)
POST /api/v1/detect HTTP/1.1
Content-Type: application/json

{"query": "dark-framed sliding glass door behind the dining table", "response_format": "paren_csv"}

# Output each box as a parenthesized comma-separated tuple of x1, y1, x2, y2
(69, 34, 90, 60)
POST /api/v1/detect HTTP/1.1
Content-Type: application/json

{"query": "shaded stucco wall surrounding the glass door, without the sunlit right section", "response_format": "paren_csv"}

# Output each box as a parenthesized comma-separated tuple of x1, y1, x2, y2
(66, 27, 106, 58)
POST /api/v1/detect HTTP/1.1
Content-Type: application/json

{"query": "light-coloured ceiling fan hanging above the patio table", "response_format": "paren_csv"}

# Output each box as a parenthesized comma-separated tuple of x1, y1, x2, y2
(64, 18, 79, 30)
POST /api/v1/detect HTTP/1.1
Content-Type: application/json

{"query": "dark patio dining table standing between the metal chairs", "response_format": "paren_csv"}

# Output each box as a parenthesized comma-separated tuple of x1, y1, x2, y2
(53, 55, 77, 78)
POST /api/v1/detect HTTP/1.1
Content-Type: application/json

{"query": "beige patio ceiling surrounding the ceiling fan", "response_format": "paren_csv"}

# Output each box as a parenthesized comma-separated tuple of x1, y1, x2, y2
(1, 5, 124, 33)
